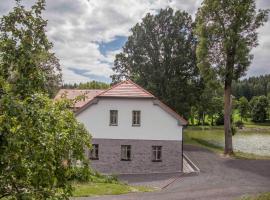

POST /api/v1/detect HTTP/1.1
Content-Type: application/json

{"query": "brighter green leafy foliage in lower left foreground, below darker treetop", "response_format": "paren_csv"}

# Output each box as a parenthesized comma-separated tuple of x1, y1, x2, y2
(0, 94, 90, 199)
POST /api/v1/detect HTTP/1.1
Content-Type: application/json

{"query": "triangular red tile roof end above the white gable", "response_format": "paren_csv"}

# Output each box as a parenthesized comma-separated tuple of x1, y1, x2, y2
(98, 80, 155, 98)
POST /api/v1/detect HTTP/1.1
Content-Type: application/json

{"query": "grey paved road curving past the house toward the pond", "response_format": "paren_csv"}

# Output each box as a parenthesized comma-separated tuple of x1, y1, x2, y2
(74, 145, 270, 200)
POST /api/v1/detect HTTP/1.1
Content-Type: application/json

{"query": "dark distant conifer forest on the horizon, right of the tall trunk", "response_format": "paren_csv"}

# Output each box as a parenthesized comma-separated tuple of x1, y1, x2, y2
(232, 74, 270, 101)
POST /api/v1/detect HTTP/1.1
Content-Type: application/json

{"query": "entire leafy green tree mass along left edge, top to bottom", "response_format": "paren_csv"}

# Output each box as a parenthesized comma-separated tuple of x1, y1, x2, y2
(0, 0, 90, 200)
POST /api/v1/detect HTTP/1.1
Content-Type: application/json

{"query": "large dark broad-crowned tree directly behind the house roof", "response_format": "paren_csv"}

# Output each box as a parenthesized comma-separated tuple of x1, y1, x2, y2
(112, 8, 201, 117)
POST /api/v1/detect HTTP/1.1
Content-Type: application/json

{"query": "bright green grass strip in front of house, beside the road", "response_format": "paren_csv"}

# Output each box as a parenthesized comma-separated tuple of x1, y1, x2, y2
(73, 183, 156, 197)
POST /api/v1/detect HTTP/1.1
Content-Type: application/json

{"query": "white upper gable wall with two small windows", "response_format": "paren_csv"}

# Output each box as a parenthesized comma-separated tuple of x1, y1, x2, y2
(77, 98, 182, 141)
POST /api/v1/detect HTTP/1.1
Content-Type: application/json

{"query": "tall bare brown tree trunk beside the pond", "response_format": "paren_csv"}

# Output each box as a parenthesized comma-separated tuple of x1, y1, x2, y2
(224, 80, 233, 155)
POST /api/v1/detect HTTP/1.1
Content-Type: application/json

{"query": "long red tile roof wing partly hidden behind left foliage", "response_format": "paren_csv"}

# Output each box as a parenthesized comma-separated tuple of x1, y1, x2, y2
(54, 89, 105, 110)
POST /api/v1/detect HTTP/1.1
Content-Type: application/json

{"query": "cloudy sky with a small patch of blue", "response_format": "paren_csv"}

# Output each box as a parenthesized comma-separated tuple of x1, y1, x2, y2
(0, 0, 270, 83)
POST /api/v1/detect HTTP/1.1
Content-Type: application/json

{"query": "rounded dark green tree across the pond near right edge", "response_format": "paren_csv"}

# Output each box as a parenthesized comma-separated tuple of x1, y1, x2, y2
(250, 96, 268, 122)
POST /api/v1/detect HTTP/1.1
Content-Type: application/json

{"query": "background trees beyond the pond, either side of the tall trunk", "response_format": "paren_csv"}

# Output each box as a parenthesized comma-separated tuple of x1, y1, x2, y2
(189, 75, 270, 125)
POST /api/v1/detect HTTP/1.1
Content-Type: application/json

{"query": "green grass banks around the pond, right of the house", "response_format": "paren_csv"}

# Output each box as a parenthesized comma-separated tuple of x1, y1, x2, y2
(184, 125, 270, 159)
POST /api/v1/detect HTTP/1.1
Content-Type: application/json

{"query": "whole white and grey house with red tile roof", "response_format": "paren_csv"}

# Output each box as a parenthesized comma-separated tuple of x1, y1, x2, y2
(53, 80, 187, 174)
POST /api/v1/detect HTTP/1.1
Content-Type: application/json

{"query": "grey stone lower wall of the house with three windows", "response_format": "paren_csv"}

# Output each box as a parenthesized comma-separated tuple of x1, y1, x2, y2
(91, 138, 182, 174)
